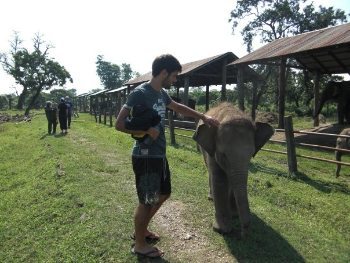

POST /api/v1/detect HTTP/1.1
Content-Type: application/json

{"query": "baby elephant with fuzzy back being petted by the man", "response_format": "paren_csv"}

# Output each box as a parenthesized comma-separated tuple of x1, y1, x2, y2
(193, 103, 274, 238)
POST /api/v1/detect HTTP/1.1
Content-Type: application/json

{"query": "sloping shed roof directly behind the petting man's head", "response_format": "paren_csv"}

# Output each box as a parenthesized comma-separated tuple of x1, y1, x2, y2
(124, 52, 257, 87)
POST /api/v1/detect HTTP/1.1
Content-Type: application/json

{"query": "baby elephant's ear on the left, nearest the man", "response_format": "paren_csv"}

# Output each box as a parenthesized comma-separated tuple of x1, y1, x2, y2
(192, 123, 217, 156)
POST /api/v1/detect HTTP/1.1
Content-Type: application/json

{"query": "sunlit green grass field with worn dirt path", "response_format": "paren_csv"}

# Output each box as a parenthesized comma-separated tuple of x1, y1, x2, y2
(0, 112, 350, 262)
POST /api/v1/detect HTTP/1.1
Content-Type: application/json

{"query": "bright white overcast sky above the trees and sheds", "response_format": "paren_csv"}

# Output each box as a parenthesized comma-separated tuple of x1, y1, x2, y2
(0, 0, 350, 94)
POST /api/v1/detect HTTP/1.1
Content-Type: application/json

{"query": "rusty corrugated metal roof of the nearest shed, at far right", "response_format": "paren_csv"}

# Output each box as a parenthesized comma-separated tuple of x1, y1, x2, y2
(232, 23, 350, 73)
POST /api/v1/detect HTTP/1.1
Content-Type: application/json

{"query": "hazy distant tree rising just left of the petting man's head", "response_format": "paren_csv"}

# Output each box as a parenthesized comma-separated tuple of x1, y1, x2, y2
(96, 55, 138, 90)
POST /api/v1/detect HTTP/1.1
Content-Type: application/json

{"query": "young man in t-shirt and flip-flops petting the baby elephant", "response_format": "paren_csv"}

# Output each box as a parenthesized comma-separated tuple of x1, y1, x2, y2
(116, 55, 218, 257)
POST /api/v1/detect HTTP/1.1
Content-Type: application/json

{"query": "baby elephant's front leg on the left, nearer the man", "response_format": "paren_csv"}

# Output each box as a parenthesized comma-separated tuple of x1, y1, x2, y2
(209, 158, 232, 234)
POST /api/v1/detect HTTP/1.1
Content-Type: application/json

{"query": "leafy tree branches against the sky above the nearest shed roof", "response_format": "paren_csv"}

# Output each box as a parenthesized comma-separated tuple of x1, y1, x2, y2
(229, 0, 347, 52)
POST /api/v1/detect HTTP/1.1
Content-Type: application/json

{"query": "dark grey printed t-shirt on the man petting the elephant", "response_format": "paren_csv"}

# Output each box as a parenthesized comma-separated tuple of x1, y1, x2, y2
(124, 83, 171, 157)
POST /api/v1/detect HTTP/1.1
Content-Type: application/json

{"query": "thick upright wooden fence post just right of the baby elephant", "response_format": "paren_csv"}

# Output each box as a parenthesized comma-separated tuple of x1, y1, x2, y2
(284, 116, 298, 173)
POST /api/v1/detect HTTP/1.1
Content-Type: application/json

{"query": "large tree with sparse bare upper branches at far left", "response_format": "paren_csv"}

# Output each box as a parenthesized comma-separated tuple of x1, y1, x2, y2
(0, 33, 73, 115)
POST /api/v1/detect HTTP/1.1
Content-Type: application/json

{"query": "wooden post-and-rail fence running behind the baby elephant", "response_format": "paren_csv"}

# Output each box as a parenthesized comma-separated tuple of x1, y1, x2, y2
(166, 111, 350, 173)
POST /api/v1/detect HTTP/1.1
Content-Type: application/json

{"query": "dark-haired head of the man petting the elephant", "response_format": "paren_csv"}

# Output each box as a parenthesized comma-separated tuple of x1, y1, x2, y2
(152, 54, 182, 89)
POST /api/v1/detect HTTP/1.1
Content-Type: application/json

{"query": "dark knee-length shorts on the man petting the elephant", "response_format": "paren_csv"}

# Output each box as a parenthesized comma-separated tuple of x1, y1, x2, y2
(132, 156, 171, 205)
